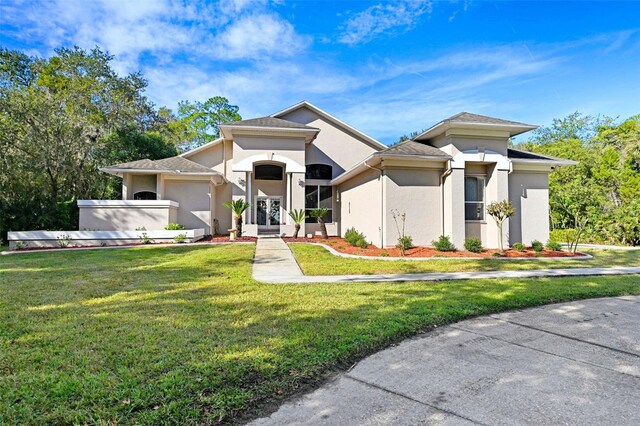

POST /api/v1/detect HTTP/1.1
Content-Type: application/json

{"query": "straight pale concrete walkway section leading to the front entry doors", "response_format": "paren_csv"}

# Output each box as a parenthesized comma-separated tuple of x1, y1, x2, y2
(253, 236, 304, 282)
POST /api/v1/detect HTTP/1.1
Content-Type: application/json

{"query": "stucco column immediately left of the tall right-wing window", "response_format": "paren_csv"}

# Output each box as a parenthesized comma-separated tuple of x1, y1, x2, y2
(442, 168, 465, 249)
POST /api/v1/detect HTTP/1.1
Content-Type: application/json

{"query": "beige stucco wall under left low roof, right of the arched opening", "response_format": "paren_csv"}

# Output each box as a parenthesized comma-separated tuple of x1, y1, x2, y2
(165, 180, 212, 234)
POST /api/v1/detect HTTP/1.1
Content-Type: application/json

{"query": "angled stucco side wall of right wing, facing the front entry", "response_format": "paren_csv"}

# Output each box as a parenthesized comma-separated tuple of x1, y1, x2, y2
(338, 170, 383, 247)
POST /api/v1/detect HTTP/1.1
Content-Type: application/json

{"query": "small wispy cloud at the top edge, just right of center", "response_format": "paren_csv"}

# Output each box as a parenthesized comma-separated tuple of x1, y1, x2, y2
(338, 0, 432, 45)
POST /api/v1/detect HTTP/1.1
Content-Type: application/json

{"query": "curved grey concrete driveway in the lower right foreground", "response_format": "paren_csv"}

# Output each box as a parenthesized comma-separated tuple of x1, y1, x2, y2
(252, 296, 640, 425)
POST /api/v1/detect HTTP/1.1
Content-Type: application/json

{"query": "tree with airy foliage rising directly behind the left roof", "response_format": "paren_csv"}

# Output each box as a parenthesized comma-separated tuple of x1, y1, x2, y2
(171, 96, 242, 150)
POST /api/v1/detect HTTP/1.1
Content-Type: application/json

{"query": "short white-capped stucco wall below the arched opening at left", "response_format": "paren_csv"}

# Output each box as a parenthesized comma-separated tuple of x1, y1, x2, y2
(78, 200, 179, 231)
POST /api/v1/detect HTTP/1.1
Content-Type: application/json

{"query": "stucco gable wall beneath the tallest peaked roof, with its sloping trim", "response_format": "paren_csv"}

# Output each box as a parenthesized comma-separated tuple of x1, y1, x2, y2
(282, 108, 379, 178)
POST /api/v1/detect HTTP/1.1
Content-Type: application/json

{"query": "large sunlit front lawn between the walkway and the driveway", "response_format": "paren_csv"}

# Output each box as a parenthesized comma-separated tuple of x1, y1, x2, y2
(0, 245, 640, 425)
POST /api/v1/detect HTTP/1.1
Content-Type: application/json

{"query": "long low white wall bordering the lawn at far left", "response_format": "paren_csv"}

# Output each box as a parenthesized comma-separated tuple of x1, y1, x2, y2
(7, 229, 204, 250)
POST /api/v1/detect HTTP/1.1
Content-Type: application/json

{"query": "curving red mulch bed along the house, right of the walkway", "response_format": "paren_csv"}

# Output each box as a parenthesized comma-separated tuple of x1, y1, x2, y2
(283, 237, 582, 258)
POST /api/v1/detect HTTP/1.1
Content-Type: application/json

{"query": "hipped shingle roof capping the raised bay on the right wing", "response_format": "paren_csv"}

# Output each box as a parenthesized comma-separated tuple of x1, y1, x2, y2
(414, 112, 538, 140)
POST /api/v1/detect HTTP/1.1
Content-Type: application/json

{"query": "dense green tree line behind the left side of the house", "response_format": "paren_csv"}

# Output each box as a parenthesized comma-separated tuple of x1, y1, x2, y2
(0, 47, 241, 238)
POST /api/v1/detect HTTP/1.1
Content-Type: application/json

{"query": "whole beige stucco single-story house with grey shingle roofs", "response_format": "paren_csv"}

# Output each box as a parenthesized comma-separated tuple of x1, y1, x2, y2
(78, 101, 574, 247)
